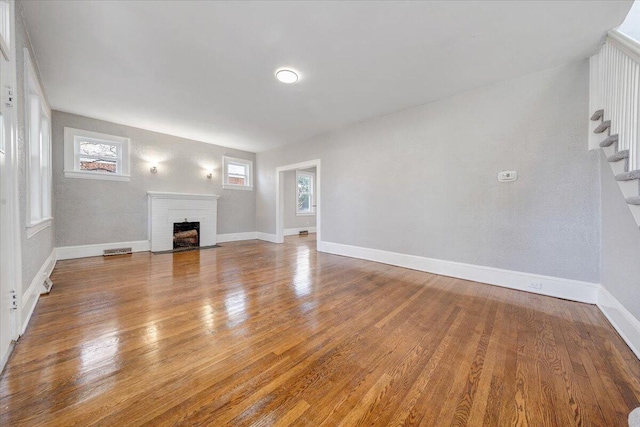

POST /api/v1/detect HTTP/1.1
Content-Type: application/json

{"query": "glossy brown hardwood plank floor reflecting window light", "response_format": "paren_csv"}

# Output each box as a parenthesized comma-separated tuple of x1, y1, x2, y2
(0, 235, 640, 426)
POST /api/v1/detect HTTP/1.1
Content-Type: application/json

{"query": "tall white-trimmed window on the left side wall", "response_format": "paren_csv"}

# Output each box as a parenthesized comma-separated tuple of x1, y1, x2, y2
(24, 48, 52, 241)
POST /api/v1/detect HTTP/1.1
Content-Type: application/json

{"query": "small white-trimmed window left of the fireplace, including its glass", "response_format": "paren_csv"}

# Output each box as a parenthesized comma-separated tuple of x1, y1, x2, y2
(64, 127, 130, 181)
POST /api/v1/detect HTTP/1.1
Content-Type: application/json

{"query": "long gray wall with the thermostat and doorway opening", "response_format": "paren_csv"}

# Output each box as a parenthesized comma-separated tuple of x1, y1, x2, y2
(257, 61, 600, 282)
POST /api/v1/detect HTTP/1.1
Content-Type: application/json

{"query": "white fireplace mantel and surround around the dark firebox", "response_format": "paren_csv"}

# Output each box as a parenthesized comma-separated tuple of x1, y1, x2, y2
(147, 191, 220, 252)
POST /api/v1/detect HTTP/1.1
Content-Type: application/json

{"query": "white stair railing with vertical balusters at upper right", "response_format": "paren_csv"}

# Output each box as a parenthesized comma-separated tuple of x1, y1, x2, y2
(589, 30, 640, 171)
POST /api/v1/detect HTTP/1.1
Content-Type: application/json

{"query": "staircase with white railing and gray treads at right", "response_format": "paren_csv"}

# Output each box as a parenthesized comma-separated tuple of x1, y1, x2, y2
(589, 30, 640, 226)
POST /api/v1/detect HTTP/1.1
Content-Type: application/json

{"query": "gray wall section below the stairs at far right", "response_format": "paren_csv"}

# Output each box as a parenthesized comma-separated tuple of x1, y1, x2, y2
(599, 150, 640, 319)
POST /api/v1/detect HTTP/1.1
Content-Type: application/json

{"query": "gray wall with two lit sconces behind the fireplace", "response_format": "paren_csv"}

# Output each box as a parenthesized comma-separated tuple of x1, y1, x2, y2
(53, 111, 256, 247)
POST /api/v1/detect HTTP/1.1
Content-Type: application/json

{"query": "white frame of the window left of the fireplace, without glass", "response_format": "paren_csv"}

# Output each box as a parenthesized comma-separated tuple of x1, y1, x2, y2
(64, 127, 131, 182)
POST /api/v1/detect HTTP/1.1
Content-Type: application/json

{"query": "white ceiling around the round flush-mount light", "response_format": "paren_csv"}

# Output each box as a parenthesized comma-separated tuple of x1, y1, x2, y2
(22, 1, 632, 152)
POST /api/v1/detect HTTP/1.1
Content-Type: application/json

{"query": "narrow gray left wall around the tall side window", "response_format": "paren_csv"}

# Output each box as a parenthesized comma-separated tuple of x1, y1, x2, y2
(15, 2, 55, 294)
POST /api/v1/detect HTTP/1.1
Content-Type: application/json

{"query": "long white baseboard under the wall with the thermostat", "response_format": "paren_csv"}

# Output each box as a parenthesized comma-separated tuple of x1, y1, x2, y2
(318, 242, 600, 304)
